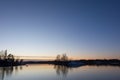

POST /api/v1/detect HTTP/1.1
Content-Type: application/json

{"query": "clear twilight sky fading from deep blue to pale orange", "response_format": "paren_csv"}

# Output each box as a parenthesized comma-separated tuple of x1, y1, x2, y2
(0, 0, 120, 58)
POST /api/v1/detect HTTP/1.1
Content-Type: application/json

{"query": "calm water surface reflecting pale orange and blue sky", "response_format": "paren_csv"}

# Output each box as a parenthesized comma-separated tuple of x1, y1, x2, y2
(0, 65, 120, 80)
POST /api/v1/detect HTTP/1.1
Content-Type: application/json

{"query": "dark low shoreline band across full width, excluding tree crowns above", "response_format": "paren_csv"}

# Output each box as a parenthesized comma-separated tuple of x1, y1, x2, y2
(0, 59, 120, 67)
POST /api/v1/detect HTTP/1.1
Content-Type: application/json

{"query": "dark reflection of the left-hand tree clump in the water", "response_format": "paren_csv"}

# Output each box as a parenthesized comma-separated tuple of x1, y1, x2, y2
(0, 66, 22, 80)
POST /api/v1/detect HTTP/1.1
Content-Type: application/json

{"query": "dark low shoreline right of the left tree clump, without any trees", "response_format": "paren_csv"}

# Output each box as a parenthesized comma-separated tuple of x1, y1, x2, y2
(24, 59, 120, 67)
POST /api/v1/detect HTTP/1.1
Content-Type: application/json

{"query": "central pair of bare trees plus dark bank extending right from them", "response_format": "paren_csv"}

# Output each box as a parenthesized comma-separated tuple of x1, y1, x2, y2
(54, 54, 120, 67)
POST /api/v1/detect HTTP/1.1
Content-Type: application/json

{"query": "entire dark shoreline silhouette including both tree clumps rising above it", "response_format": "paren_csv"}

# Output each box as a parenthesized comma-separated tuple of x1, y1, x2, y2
(0, 50, 120, 67)
